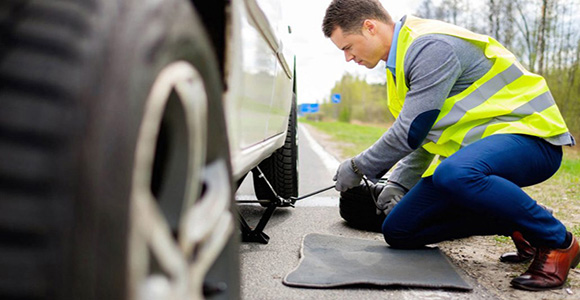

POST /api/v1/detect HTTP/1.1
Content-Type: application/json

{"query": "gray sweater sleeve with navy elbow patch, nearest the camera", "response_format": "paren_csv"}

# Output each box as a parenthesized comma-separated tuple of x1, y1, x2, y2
(354, 36, 462, 183)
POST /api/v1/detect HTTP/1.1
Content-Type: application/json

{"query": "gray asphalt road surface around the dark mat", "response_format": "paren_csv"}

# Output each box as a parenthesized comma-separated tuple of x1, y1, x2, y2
(236, 128, 497, 300)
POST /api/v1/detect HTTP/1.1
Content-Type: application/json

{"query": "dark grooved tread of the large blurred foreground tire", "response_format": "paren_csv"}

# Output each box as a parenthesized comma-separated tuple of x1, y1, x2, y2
(0, 0, 95, 300)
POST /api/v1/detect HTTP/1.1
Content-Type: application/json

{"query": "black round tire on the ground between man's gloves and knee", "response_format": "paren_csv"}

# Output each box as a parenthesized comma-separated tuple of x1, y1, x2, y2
(339, 183, 385, 232)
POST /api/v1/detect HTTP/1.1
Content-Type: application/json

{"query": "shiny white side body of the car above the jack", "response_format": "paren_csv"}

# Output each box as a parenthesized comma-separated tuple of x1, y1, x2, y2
(224, 0, 294, 180)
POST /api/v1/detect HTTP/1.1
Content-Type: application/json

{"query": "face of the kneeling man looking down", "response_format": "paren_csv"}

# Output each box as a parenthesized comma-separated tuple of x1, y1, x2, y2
(330, 22, 388, 69)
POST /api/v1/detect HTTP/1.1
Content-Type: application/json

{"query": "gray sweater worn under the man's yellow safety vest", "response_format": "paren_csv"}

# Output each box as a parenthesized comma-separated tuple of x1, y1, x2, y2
(354, 34, 574, 189)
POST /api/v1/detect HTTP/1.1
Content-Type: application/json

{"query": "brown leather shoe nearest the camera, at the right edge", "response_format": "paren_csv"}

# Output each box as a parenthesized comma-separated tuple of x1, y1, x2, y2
(511, 237, 580, 291)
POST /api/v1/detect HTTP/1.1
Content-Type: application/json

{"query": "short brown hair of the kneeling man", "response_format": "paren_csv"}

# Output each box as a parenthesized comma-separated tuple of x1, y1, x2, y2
(322, 0, 393, 38)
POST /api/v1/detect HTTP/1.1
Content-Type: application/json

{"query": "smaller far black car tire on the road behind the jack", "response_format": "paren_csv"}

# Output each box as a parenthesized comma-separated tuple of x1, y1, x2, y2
(252, 94, 298, 206)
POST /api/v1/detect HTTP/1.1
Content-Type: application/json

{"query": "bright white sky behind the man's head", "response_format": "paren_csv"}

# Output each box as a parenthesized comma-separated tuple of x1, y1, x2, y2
(284, 0, 421, 103)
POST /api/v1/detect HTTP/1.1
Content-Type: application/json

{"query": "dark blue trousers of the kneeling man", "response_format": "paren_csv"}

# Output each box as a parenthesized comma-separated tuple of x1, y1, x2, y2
(382, 134, 566, 248)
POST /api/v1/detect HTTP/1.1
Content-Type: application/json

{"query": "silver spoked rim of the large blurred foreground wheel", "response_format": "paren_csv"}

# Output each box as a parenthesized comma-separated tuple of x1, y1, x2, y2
(130, 62, 235, 300)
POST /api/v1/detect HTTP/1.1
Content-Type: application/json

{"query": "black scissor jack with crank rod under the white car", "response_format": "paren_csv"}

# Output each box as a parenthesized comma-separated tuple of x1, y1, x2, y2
(236, 167, 334, 244)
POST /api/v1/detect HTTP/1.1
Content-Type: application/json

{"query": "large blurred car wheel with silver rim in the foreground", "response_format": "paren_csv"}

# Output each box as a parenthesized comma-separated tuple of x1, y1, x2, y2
(0, 0, 239, 299)
